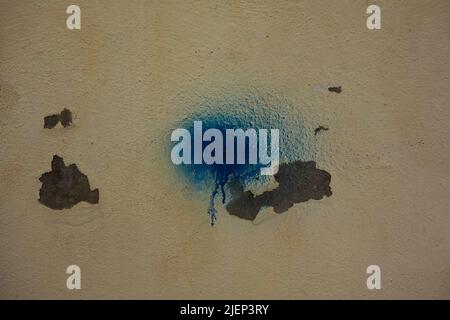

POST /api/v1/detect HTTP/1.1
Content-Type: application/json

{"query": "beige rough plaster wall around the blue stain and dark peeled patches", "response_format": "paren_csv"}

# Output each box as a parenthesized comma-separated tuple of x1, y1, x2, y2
(0, 0, 450, 299)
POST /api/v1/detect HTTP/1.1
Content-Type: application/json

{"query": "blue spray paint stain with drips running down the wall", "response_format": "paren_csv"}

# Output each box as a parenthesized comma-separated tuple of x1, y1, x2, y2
(169, 95, 314, 225)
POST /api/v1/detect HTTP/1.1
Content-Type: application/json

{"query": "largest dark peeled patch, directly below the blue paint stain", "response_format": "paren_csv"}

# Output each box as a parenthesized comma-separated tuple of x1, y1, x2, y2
(226, 161, 332, 220)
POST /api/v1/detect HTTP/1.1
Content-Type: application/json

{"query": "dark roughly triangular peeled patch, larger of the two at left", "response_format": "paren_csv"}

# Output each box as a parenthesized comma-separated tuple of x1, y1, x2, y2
(39, 155, 99, 210)
